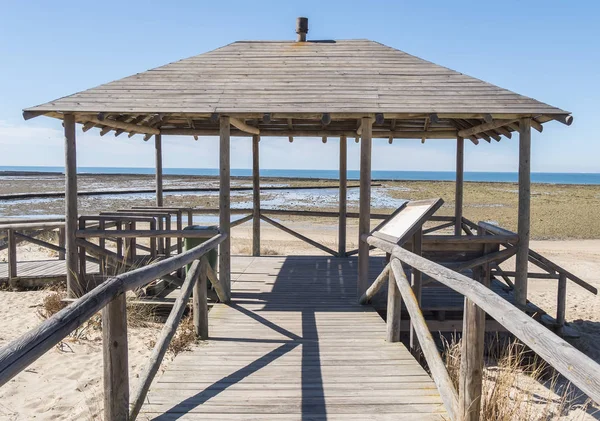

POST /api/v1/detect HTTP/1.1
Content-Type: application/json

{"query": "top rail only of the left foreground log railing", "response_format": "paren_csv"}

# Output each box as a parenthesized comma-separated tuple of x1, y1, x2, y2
(0, 233, 227, 386)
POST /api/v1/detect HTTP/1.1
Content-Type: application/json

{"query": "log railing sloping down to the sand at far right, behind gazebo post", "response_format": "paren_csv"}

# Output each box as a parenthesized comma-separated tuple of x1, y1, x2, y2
(463, 218, 598, 331)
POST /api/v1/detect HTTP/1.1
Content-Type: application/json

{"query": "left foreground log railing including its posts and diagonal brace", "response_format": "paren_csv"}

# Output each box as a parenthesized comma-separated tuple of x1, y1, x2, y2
(0, 231, 229, 421)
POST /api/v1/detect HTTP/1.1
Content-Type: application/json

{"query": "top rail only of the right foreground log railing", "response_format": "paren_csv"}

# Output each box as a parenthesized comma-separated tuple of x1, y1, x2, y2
(362, 236, 600, 403)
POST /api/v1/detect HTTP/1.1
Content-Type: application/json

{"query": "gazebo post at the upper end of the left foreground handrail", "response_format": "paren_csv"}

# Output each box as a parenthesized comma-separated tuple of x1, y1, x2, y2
(219, 116, 231, 302)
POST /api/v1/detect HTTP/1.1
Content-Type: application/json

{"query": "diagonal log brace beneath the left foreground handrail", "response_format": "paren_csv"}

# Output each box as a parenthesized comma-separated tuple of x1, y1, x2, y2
(129, 260, 208, 421)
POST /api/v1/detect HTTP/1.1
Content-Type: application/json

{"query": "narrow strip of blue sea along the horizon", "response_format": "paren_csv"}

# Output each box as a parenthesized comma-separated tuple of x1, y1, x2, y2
(0, 166, 600, 185)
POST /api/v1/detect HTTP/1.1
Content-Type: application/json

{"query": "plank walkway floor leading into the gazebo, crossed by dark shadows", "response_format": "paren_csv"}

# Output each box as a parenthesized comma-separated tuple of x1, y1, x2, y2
(139, 256, 447, 421)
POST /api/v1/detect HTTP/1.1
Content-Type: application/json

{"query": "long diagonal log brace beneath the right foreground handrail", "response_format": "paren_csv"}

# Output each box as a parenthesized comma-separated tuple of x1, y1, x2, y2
(390, 257, 461, 420)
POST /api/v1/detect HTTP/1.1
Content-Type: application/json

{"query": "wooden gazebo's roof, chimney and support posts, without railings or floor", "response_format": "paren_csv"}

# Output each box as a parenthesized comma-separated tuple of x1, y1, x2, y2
(24, 18, 572, 305)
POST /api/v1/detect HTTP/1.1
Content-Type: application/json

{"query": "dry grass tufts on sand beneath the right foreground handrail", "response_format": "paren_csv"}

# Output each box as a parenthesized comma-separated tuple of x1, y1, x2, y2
(443, 338, 596, 421)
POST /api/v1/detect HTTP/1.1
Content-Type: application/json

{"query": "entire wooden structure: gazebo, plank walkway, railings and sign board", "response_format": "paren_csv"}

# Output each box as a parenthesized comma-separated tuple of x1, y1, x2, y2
(0, 18, 600, 421)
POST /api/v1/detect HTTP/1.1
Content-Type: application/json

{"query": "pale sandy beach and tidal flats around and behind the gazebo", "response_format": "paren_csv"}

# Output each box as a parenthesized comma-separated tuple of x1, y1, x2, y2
(0, 172, 600, 421)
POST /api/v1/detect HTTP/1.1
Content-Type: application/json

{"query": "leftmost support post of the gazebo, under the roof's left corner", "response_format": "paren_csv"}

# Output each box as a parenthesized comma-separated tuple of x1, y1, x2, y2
(64, 114, 79, 298)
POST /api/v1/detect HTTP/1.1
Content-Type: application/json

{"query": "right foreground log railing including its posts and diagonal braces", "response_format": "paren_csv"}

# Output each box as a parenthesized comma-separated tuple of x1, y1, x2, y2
(362, 234, 600, 421)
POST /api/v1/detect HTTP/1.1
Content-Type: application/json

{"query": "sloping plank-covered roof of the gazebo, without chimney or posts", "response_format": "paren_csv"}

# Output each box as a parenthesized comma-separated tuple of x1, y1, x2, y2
(26, 40, 568, 115)
